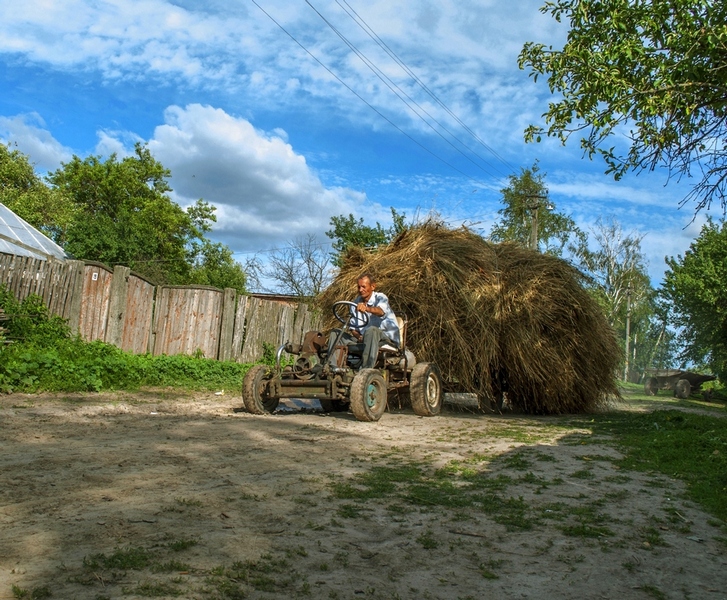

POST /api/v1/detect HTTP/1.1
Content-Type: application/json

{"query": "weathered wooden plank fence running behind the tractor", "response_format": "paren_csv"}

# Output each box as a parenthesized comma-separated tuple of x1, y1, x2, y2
(0, 253, 319, 362)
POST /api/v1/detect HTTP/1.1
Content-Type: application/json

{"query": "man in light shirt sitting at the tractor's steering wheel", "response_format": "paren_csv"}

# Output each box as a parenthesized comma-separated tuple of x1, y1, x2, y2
(328, 273, 401, 369)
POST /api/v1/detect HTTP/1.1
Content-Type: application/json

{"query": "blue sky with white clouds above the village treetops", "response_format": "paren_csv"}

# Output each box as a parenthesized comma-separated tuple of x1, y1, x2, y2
(0, 0, 717, 285)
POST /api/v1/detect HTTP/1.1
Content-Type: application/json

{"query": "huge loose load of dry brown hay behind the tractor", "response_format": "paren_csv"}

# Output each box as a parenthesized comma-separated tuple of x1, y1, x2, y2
(319, 223, 620, 414)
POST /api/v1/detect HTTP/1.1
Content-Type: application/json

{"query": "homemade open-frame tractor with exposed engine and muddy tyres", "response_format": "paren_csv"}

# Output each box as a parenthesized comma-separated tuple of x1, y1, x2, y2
(242, 300, 442, 421)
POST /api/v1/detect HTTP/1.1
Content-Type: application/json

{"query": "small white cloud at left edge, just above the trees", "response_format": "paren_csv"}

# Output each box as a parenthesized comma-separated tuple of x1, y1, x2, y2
(0, 113, 73, 172)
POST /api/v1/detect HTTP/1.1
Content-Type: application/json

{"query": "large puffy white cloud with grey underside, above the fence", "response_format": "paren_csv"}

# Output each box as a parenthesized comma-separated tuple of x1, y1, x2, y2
(142, 104, 365, 252)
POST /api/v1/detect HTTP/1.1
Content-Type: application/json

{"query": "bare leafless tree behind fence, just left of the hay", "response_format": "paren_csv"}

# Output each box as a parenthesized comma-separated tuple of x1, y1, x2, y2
(263, 234, 332, 298)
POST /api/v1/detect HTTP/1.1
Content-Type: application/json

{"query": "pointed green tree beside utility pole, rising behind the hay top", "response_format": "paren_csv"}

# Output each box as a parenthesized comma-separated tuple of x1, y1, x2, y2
(490, 162, 585, 256)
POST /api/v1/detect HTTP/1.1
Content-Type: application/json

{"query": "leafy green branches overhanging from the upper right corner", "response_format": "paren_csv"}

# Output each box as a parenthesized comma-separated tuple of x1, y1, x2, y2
(518, 0, 727, 210)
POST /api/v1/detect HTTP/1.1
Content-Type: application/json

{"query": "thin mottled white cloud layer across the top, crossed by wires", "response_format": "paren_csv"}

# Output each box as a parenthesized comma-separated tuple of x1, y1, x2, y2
(0, 0, 562, 154)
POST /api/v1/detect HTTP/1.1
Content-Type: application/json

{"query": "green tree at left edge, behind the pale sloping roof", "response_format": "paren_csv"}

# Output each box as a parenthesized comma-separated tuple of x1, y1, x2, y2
(0, 144, 75, 245)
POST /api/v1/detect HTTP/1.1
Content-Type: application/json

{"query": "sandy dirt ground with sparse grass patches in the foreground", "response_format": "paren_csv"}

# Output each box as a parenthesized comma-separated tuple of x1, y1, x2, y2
(0, 390, 727, 600)
